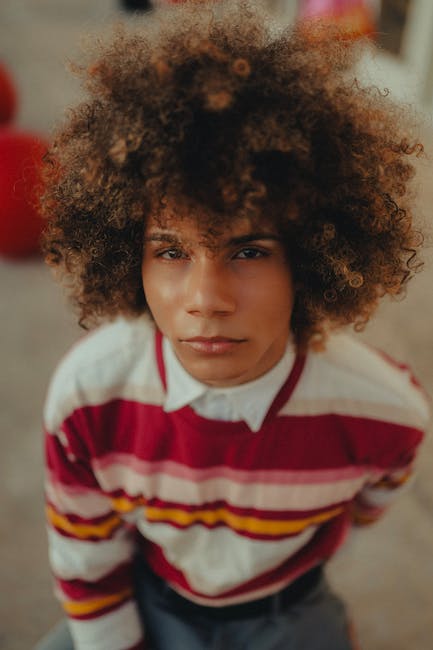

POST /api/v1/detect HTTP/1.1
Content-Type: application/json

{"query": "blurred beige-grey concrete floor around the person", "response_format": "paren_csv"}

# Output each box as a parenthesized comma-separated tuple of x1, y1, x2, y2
(0, 0, 433, 650)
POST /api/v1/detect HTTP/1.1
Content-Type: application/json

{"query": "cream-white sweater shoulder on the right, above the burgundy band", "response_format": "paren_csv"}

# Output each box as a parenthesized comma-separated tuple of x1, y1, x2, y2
(287, 333, 430, 429)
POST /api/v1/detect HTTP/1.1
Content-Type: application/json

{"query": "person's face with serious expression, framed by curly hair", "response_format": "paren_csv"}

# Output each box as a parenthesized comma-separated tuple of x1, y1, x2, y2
(142, 217, 293, 386)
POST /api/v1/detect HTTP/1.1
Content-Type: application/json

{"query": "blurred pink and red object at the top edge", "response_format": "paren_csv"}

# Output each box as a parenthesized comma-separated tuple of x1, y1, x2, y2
(298, 0, 377, 38)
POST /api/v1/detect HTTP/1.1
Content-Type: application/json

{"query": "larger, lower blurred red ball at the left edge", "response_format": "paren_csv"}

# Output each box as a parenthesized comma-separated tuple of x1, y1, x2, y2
(0, 127, 48, 258)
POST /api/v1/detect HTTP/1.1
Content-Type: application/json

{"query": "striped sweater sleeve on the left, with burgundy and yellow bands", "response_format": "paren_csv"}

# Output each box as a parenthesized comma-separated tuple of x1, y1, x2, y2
(46, 418, 146, 650)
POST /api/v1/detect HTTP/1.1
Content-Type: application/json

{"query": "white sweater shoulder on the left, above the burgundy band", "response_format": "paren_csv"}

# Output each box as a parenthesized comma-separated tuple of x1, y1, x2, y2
(44, 317, 162, 431)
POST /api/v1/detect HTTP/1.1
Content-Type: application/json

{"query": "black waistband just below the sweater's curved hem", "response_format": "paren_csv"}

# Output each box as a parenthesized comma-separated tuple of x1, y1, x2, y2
(159, 565, 323, 621)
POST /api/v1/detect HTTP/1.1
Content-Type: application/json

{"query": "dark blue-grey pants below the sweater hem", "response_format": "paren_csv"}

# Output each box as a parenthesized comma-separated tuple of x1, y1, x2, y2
(34, 567, 353, 650)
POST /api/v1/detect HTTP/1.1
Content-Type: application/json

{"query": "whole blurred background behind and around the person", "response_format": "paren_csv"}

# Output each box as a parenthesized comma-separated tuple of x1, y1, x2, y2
(0, 0, 433, 650)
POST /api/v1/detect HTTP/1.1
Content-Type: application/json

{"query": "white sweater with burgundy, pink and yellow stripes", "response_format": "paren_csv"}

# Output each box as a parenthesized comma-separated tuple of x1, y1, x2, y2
(44, 318, 428, 650)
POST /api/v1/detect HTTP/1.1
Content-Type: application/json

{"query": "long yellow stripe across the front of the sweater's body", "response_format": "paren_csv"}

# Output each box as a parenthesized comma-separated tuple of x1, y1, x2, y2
(146, 507, 343, 535)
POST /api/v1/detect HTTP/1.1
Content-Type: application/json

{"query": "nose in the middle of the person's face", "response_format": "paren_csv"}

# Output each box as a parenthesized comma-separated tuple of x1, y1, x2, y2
(185, 256, 236, 318)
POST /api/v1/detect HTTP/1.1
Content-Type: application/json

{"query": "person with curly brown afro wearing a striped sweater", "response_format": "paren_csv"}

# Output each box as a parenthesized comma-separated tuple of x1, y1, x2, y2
(38, 1, 428, 650)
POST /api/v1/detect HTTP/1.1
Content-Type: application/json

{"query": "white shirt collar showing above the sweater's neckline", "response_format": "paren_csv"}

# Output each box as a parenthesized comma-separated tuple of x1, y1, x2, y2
(163, 338, 296, 432)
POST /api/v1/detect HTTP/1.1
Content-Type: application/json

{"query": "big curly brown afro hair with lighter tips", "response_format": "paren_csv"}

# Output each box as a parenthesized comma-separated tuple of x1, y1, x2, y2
(42, 1, 422, 346)
